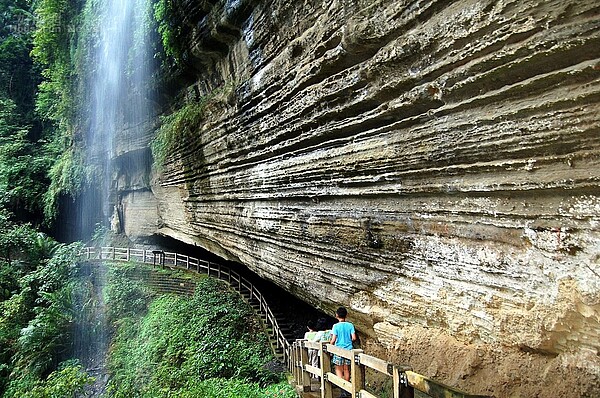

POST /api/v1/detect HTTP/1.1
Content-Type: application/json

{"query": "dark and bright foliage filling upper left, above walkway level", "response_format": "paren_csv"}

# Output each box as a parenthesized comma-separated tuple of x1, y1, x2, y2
(0, 0, 81, 224)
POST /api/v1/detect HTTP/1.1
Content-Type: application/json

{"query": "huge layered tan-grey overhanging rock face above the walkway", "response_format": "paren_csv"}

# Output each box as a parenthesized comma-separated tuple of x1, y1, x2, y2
(113, 0, 600, 397)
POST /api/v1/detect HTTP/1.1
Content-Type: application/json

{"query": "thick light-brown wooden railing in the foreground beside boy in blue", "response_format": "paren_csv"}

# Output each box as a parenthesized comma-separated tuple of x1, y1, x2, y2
(291, 340, 489, 398)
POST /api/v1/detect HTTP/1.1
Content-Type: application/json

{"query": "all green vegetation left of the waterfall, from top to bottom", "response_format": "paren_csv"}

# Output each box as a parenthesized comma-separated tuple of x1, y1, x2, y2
(0, 0, 94, 398)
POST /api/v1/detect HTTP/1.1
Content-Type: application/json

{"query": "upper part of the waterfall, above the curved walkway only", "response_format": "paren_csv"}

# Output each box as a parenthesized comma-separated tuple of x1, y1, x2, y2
(80, 0, 154, 238)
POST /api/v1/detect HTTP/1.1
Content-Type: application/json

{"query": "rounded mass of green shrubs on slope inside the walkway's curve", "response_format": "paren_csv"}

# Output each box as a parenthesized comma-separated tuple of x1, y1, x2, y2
(109, 278, 293, 397)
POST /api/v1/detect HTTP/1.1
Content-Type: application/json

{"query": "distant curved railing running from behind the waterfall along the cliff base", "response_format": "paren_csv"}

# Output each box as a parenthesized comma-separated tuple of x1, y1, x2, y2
(81, 247, 291, 368)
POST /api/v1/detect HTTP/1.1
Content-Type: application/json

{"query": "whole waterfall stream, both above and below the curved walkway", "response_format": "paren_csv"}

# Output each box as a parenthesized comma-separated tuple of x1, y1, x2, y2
(74, 0, 152, 397)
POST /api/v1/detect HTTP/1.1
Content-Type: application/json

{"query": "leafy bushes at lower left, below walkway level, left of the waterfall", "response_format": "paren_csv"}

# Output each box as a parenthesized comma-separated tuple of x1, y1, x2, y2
(0, 233, 81, 397)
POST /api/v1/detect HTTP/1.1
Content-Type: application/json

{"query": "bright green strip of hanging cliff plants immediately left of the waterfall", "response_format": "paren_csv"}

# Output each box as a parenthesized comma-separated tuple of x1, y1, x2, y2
(31, 0, 92, 221)
